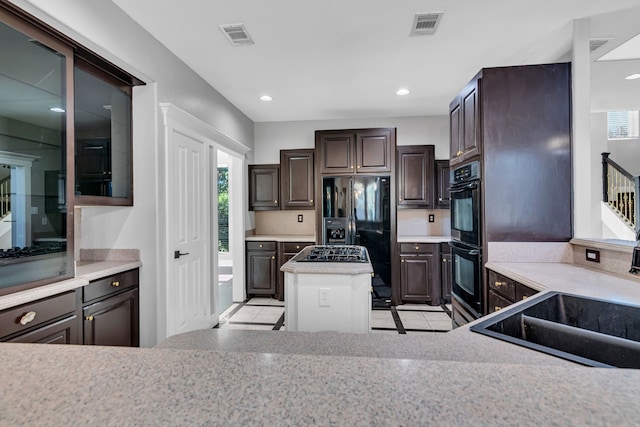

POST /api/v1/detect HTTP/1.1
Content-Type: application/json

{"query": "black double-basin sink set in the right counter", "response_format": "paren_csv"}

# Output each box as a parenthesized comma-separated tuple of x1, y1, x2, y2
(470, 292, 640, 369)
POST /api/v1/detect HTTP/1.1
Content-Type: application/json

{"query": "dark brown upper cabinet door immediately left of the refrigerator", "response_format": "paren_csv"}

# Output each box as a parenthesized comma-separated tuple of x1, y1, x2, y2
(280, 150, 315, 209)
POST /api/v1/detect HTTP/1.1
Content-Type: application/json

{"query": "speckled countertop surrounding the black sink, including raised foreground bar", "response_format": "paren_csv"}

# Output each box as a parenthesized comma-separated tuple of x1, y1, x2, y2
(0, 263, 640, 426)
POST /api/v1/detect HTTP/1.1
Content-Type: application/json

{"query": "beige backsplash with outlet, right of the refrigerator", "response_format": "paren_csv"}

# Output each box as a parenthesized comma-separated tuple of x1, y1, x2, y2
(398, 209, 451, 236)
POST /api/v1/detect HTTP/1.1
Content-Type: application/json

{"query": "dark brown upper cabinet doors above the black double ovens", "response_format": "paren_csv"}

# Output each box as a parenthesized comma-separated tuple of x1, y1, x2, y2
(449, 76, 482, 166)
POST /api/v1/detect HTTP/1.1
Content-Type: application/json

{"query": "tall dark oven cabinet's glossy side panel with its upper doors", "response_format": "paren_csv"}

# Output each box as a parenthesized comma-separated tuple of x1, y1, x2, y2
(450, 63, 573, 247)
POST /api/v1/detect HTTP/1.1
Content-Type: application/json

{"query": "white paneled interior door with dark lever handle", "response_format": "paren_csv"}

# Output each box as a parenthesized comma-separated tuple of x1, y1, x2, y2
(167, 131, 218, 336)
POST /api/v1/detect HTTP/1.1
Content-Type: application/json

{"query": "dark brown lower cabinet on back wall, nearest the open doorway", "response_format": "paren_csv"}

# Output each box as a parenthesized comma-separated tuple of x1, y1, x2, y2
(246, 241, 278, 297)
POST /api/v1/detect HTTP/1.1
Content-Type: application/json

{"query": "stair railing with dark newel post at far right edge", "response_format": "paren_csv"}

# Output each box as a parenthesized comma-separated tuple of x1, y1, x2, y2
(602, 153, 640, 233)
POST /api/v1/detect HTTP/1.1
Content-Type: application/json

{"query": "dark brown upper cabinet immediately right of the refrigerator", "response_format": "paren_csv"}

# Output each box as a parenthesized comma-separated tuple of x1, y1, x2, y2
(397, 145, 434, 208)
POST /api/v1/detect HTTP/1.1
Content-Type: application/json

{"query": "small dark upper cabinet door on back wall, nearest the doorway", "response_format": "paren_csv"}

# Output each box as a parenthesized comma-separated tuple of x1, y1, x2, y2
(249, 165, 280, 211)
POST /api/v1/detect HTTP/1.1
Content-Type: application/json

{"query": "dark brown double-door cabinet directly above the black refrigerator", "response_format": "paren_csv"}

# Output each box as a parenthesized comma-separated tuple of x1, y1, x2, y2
(316, 128, 396, 175)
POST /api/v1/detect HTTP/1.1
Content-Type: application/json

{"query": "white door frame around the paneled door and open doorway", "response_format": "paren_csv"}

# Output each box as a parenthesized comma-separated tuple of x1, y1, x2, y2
(156, 103, 250, 342)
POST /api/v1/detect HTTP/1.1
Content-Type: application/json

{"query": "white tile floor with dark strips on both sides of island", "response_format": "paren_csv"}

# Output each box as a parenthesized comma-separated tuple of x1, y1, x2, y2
(217, 298, 451, 334)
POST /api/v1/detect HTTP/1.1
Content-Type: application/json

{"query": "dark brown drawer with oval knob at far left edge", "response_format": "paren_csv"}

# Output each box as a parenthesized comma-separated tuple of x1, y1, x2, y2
(0, 291, 76, 337)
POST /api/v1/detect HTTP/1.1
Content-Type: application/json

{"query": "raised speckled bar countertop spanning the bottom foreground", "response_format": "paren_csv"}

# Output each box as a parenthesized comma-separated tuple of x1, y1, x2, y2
(0, 340, 640, 426)
